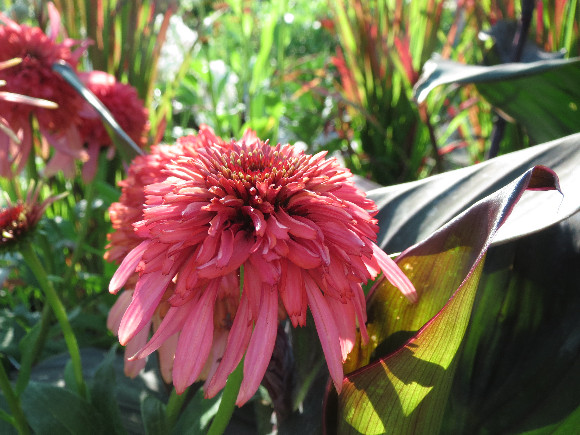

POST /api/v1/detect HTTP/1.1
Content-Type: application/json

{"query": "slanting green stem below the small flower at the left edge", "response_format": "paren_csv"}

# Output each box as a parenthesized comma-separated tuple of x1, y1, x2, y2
(20, 243, 86, 397)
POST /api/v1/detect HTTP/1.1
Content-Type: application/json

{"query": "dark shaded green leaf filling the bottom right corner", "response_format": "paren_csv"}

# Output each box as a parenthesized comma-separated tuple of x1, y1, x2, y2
(442, 214, 580, 434)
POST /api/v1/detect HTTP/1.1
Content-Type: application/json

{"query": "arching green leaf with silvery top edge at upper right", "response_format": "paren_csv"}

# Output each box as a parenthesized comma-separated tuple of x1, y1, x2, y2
(414, 58, 580, 143)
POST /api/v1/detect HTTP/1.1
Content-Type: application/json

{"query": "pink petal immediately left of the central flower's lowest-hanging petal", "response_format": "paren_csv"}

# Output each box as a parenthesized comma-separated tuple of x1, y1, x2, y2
(205, 297, 252, 398)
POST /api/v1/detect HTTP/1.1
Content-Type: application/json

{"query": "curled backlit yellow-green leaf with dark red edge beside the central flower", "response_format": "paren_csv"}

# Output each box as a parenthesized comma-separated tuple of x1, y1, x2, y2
(326, 167, 558, 434)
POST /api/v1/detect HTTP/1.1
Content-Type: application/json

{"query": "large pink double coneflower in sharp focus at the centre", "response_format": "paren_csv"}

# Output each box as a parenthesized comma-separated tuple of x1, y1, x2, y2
(109, 129, 416, 405)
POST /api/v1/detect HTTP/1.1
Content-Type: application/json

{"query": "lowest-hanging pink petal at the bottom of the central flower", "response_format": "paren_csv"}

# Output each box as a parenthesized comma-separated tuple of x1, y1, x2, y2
(236, 286, 278, 406)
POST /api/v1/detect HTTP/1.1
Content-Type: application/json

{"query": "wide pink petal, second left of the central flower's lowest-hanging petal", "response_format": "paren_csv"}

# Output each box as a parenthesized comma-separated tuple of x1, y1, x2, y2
(173, 280, 218, 394)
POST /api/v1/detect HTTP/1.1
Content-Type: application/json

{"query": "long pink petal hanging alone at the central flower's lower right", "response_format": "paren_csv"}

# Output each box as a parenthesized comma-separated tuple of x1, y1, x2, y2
(304, 274, 343, 393)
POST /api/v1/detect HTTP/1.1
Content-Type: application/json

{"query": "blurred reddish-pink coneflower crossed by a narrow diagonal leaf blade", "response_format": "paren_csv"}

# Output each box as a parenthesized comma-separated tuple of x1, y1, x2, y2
(79, 71, 148, 180)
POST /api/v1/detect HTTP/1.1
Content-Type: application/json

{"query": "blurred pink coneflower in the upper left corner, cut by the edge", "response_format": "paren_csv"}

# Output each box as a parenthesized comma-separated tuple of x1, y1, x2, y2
(0, 14, 86, 176)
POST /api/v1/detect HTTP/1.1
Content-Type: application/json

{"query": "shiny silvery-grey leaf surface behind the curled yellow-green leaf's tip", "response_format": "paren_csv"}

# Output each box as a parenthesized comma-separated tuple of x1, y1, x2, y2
(368, 134, 580, 253)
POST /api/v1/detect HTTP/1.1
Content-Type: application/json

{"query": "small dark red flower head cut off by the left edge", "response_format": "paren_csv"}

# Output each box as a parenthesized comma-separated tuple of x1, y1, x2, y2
(0, 184, 66, 251)
